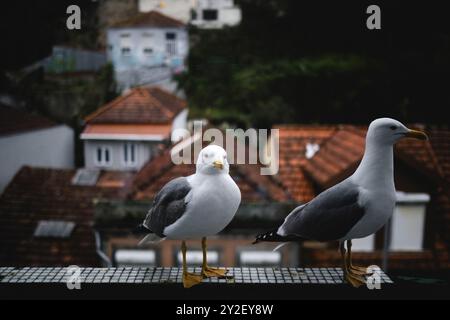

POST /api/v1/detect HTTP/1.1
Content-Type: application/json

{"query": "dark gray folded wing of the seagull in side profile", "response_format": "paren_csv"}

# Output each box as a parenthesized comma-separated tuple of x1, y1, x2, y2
(280, 180, 364, 241)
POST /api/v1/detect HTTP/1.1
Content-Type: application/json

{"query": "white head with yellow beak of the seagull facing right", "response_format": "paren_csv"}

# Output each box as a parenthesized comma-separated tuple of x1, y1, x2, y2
(367, 118, 428, 145)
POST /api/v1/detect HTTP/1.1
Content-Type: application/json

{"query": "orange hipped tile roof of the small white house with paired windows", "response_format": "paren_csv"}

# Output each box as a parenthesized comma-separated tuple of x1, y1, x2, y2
(85, 87, 186, 124)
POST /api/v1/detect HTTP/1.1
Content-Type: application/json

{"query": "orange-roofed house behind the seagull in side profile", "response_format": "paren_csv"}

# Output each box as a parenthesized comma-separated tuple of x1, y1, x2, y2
(277, 125, 450, 270)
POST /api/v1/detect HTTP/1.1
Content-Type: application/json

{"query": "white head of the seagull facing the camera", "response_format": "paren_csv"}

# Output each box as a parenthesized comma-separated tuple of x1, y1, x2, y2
(197, 145, 230, 174)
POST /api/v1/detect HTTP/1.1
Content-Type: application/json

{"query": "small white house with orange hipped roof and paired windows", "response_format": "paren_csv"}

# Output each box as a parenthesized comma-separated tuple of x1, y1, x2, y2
(81, 87, 188, 171)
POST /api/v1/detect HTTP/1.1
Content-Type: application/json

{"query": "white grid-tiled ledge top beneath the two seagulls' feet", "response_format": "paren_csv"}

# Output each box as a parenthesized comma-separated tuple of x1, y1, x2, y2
(0, 267, 393, 285)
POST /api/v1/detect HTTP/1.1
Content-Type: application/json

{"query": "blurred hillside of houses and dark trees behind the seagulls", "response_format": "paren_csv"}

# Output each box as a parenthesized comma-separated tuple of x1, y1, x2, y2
(0, 0, 450, 278)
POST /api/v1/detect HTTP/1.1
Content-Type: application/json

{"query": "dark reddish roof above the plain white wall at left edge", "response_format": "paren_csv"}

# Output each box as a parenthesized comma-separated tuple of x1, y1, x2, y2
(0, 105, 57, 135)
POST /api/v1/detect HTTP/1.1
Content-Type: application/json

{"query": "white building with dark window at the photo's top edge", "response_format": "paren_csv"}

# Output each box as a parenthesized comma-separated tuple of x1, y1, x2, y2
(191, 0, 242, 29)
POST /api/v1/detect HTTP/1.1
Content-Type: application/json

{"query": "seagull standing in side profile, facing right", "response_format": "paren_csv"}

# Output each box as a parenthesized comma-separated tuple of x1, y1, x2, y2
(254, 118, 427, 287)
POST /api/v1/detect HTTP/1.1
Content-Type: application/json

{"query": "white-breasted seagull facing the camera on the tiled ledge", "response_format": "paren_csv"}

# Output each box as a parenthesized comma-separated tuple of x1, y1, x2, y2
(140, 145, 241, 288)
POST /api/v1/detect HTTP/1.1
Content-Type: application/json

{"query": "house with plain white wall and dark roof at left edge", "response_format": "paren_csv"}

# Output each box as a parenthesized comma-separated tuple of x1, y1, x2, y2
(0, 105, 75, 193)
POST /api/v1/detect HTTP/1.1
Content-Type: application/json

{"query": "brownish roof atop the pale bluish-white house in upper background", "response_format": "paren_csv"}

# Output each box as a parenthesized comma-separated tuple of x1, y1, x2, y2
(112, 11, 185, 28)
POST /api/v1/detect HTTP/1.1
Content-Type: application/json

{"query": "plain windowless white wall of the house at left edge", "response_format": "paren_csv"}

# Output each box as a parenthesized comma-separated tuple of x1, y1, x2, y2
(0, 125, 74, 192)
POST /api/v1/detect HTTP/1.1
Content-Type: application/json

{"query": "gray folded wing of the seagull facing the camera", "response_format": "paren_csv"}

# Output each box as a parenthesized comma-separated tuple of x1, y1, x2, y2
(143, 177, 191, 238)
